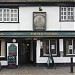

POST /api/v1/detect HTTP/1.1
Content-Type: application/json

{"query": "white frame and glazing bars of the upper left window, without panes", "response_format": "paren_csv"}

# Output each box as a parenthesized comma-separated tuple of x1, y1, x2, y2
(0, 8, 18, 22)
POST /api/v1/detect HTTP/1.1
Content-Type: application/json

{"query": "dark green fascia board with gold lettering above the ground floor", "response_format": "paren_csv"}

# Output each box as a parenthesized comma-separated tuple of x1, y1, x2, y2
(0, 31, 75, 38)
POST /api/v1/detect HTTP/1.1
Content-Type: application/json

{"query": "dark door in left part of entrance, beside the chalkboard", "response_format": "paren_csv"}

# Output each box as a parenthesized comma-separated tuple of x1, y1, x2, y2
(19, 41, 30, 65)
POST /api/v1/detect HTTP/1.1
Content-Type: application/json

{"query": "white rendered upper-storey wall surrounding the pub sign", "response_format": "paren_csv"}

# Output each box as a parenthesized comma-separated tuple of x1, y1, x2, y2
(0, 6, 75, 31)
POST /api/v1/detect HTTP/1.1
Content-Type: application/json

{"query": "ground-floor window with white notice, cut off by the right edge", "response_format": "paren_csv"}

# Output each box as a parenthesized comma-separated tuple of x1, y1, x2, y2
(65, 39, 75, 55)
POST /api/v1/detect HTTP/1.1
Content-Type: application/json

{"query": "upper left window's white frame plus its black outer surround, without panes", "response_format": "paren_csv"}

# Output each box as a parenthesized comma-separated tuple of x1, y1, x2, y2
(0, 7, 19, 23)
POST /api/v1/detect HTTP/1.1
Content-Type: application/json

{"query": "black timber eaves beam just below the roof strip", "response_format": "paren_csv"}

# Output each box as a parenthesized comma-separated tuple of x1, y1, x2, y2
(0, 2, 75, 7)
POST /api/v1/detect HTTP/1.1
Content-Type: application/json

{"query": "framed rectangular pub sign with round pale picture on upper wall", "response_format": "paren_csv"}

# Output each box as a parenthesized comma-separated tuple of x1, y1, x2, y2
(33, 12, 46, 31)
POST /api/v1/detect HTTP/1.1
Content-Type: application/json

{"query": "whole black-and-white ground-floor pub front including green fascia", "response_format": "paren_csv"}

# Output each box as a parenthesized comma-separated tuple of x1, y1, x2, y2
(0, 31, 75, 66)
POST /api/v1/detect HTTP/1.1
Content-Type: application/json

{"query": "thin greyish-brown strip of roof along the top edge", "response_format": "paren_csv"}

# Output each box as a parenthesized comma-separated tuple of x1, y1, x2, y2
(0, 0, 75, 2)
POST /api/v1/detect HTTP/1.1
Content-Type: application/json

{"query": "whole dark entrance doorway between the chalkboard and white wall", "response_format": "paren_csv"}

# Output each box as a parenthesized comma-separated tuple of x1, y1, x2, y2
(18, 40, 36, 66)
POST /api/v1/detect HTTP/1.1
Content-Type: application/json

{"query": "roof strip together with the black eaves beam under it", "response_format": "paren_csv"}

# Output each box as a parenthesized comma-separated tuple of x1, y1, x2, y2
(0, 0, 75, 7)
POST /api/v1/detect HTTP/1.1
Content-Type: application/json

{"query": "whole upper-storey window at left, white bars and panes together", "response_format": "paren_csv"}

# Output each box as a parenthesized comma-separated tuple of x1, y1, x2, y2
(0, 8, 18, 22)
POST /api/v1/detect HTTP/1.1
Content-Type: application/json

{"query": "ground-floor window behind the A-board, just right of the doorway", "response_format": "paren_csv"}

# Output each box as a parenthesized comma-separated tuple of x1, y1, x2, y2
(40, 39, 57, 56)
